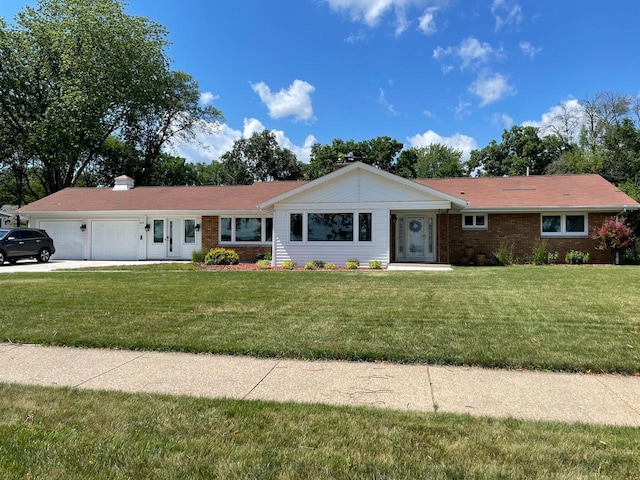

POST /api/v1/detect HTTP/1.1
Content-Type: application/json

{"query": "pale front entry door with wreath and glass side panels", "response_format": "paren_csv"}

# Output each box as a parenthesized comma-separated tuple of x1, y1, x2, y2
(396, 215, 436, 262)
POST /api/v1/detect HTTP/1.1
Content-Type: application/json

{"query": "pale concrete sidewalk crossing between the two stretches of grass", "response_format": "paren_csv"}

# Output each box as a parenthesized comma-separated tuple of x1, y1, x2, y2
(0, 344, 640, 427)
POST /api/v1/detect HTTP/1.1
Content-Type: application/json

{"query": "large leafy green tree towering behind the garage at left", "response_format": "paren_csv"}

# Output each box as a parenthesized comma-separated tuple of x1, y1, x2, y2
(0, 0, 221, 199)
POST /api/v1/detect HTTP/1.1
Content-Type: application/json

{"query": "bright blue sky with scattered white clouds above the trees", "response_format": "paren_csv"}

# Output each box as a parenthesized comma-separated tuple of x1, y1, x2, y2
(0, 0, 640, 162)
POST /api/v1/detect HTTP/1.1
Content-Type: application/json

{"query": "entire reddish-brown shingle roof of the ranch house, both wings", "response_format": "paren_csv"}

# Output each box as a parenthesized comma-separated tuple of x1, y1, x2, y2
(20, 171, 640, 213)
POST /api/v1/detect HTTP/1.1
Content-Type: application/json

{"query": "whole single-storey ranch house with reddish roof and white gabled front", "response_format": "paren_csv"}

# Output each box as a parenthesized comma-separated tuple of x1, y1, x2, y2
(20, 162, 640, 265)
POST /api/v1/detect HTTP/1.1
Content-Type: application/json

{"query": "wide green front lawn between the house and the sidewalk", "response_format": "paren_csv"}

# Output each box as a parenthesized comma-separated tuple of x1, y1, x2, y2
(0, 265, 640, 374)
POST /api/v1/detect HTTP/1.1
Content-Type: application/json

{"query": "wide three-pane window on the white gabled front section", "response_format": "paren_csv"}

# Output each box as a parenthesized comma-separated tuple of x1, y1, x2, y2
(289, 211, 373, 243)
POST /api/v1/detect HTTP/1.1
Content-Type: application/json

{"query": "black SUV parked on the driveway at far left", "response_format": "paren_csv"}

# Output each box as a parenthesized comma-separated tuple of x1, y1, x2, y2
(0, 228, 56, 265)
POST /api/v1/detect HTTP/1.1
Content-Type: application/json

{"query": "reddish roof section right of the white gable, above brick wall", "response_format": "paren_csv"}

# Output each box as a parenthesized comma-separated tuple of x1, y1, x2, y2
(416, 175, 640, 211)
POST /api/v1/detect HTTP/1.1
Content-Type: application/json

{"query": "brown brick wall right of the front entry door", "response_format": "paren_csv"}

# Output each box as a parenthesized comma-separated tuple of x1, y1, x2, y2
(438, 212, 615, 265)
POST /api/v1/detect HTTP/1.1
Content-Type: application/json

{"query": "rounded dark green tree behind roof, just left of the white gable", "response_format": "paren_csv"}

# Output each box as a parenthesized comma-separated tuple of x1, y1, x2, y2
(221, 130, 304, 185)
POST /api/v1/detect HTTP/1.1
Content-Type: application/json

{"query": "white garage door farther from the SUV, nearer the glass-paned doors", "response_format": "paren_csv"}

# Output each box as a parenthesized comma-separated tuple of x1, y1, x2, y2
(91, 220, 139, 260)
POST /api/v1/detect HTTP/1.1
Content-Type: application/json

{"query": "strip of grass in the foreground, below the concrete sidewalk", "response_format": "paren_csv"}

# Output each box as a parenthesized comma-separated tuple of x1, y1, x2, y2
(0, 385, 640, 480)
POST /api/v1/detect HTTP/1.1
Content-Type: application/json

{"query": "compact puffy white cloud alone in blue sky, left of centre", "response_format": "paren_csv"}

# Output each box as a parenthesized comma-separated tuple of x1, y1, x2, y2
(251, 80, 315, 121)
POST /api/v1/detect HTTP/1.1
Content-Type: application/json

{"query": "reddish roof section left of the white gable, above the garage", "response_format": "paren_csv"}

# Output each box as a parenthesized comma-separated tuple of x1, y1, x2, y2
(20, 181, 302, 213)
